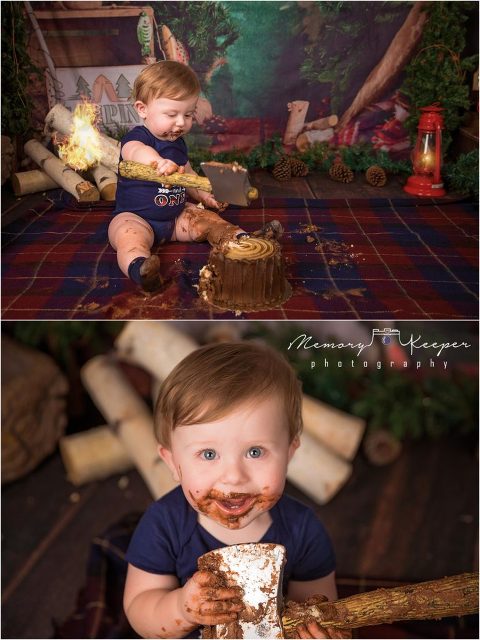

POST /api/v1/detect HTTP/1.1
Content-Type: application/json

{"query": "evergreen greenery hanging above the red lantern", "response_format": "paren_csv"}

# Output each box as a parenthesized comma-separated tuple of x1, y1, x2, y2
(401, 1, 478, 153)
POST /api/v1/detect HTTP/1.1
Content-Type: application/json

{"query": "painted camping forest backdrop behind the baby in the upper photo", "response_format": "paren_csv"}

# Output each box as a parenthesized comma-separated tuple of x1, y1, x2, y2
(25, 1, 426, 158)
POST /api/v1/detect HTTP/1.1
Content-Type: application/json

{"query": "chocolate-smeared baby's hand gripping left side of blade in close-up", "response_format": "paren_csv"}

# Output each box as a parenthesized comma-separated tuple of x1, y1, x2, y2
(180, 571, 242, 625)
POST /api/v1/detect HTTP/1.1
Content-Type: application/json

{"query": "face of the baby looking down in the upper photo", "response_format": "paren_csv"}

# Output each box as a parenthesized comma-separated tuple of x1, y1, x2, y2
(135, 96, 198, 141)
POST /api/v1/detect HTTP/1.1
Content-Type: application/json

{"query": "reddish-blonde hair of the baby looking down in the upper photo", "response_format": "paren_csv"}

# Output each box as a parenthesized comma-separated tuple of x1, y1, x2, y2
(132, 60, 201, 104)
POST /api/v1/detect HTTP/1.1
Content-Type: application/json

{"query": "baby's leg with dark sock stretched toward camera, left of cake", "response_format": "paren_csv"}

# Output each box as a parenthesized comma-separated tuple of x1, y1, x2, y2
(108, 212, 161, 291)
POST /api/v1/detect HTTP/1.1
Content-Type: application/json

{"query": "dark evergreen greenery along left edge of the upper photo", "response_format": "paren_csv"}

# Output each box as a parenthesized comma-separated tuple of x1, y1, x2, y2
(2, 2, 40, 136)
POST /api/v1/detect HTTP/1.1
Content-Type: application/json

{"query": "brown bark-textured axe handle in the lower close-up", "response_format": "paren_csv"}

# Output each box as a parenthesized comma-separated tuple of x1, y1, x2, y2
(282, 573, 478, 638)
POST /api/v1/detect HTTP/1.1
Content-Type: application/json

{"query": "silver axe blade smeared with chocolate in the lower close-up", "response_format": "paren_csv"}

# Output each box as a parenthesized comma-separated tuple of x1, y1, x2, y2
(198, 543, 286, 638)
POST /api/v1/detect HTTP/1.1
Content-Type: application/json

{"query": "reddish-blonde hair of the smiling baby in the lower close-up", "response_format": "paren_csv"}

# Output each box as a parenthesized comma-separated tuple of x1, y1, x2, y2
(154, 342, 302, 448)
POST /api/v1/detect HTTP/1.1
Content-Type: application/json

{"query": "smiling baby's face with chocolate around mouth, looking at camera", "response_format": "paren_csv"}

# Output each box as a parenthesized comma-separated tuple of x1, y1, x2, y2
(161, 396, 298, 529)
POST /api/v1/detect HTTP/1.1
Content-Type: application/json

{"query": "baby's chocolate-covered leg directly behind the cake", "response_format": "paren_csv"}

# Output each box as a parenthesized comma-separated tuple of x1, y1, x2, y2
(172, 203, 245, 246)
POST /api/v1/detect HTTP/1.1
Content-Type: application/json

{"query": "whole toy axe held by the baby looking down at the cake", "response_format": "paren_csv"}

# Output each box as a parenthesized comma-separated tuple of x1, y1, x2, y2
(118, 160, 258, 207)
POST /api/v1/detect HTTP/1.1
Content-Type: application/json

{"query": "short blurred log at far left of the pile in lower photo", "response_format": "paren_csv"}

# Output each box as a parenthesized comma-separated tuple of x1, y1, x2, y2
(59, 426, 133, 486)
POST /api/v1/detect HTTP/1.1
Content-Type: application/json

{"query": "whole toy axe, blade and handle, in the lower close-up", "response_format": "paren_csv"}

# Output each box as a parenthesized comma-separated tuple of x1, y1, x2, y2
(198, 543, 478, 638)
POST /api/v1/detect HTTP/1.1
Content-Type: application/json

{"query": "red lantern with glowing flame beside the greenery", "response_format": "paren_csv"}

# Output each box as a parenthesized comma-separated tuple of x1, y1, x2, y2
(403, 103, 445, 197)
